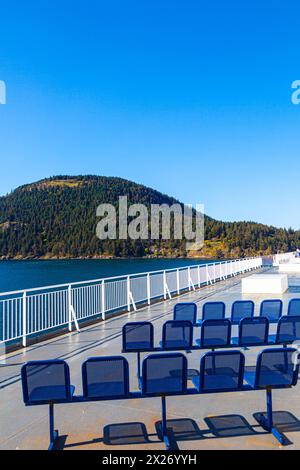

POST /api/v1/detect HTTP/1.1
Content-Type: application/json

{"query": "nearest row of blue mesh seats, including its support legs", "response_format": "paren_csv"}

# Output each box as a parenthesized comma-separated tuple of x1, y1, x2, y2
(21, 348, 299, 450)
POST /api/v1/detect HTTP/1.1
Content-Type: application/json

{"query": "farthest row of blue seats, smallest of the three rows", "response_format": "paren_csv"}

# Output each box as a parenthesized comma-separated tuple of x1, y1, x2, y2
(173, 298, 300, 325)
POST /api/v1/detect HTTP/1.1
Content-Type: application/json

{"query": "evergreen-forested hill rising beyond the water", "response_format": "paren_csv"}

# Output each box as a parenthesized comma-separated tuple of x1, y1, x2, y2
(0, 176, 300, 259)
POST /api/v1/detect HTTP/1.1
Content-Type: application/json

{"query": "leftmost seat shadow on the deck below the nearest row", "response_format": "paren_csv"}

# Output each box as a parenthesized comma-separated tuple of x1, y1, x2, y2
(103, 422, 150, 446)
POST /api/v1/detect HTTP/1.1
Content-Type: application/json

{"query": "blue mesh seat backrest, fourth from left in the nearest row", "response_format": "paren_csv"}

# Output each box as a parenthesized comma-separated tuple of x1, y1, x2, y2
(199, 350, 245, 392)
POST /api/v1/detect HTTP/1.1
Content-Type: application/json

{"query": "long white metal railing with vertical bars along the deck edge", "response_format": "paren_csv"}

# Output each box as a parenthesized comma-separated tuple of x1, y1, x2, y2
(0, 258, 262, 346)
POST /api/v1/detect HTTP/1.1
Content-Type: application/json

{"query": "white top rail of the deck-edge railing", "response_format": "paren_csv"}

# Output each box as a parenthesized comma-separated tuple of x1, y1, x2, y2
(0, 256, 261, 297)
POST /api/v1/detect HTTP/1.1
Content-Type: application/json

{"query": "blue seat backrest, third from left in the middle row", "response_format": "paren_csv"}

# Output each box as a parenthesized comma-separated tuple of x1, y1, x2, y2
(200, 318, 231, 349)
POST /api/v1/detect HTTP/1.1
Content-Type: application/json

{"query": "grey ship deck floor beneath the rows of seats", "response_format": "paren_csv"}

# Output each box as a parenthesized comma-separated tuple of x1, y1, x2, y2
(0, 271, 300, 450)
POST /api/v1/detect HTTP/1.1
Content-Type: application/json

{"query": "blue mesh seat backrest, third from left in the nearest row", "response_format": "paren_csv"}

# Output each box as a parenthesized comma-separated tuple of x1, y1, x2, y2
(142, 353, 187, 396)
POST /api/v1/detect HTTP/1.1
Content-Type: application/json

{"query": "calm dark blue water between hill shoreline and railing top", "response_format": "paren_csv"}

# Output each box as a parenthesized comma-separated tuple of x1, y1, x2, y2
(0, 259, 217, 292)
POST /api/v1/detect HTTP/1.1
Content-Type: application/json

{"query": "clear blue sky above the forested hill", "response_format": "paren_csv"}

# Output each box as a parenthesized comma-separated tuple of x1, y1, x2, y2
(0, 0, 300, 228)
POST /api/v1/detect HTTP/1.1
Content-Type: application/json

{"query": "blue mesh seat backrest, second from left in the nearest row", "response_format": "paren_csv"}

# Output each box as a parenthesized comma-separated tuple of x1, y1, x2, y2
(82, 356, 129, 399)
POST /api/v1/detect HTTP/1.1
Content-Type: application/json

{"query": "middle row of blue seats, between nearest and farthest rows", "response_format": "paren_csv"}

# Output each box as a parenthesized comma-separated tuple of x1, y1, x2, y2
(122, 316, 300, 353)
